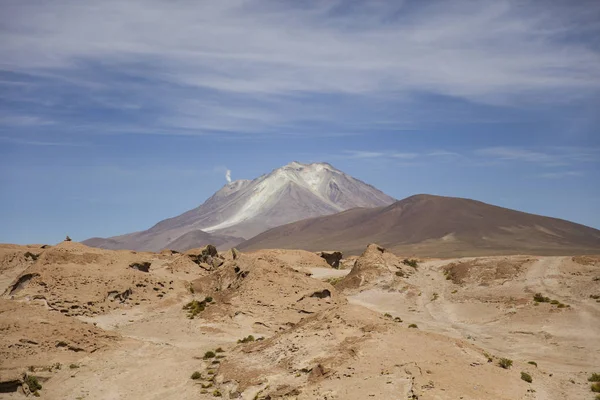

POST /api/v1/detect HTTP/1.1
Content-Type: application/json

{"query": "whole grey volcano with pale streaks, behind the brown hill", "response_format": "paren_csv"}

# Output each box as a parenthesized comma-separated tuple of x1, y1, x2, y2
(84, 161, 395, 251)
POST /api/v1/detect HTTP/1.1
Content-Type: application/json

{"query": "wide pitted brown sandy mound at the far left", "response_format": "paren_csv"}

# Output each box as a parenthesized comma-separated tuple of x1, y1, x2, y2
(5, 242, 192, 316)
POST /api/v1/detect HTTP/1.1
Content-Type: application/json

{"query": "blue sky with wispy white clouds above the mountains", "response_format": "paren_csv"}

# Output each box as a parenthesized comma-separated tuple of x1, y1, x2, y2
(0, 0, 600, 243)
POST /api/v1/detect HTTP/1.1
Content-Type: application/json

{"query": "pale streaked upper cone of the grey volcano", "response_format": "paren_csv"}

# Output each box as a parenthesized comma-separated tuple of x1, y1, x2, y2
(199, 161, 393, 238)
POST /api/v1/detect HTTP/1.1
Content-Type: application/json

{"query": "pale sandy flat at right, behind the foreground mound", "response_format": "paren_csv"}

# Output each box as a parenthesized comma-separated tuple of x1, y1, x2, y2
(342, 256, 600, 399)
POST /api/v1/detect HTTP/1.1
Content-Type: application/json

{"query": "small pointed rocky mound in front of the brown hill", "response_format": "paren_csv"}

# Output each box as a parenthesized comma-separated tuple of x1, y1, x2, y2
(336, 244, 412, 291)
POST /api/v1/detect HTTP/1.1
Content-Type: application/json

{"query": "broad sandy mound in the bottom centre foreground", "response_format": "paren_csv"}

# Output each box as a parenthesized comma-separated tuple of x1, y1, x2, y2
(201, 305, 541, 399)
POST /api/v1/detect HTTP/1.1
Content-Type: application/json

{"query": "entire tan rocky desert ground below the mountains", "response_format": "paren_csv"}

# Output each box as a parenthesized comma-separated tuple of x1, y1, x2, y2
(0, 242, 600, 400)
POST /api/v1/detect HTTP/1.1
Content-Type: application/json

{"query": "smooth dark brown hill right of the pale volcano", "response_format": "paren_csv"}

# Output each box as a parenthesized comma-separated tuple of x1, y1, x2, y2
(238, 195, 600, 256)
